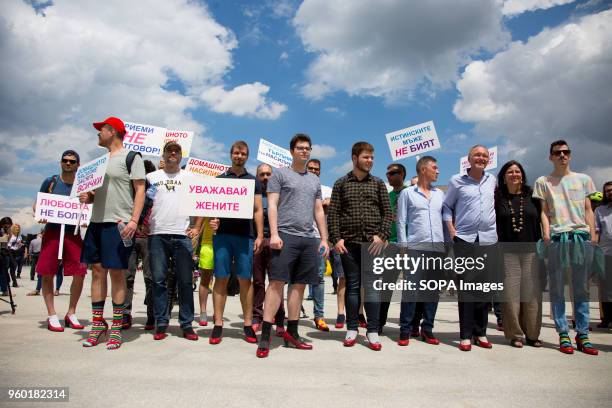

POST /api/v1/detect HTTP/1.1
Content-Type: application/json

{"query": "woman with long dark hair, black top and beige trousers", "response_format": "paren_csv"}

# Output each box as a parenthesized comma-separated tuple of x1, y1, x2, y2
(495, 160, 542, 348)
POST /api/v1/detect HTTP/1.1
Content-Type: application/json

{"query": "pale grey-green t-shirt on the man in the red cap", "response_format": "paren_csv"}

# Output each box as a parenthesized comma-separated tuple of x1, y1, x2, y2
(91, 149, 145, 222)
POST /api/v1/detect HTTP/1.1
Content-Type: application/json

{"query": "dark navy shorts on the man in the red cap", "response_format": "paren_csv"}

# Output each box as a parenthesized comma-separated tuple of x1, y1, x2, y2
(81, 222, 134, 269)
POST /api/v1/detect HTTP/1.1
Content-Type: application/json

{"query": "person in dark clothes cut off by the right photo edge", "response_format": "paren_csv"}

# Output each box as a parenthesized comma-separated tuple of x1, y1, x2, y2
(595, 181, 612, 328)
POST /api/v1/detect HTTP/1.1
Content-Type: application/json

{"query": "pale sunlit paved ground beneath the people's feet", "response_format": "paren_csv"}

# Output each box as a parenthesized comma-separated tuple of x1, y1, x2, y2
(0, 268, 612, 408)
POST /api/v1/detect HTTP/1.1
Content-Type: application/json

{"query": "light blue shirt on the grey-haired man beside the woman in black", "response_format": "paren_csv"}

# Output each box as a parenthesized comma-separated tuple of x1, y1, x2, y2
(443, 173, 497, 244)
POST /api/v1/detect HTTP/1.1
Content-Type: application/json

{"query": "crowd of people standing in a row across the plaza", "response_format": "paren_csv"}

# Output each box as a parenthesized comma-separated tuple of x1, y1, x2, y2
(0, 117, 612, 358)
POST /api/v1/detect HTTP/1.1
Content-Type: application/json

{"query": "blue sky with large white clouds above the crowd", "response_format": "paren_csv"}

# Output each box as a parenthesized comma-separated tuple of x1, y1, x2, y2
(0, 0, 612, 229)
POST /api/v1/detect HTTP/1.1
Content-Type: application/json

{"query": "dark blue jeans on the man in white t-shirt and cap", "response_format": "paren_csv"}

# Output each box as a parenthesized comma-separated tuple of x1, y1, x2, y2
(148, 234, 194, 329)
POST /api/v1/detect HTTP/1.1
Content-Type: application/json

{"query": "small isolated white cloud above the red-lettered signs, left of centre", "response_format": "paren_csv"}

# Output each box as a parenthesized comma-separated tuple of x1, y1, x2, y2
(200, 82, 287, 119)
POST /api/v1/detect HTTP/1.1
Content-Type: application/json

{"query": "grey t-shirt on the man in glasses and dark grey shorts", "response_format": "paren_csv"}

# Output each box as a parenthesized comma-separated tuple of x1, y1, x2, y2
(268, 167, 321, 238)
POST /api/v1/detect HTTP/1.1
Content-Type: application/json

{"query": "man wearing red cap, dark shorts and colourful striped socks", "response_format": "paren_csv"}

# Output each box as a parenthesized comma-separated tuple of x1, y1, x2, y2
(79, 117, 145, 350)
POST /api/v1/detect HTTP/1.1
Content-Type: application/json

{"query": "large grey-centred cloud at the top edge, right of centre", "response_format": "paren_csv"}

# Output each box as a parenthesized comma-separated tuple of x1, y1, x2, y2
(293, 0, 510, 101)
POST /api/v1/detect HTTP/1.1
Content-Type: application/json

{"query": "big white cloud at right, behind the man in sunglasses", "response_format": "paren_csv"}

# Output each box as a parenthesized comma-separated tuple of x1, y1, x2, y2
(453, 10, 612, 184)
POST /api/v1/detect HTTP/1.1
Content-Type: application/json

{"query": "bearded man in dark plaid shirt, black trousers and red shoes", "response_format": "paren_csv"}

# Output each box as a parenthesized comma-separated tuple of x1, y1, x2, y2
(328, 142, 393, 351)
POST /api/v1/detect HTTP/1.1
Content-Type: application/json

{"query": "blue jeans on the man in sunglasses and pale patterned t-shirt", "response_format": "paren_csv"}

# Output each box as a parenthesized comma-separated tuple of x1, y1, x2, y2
(548, 242, 593, 334)
